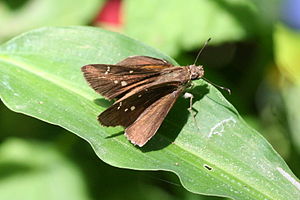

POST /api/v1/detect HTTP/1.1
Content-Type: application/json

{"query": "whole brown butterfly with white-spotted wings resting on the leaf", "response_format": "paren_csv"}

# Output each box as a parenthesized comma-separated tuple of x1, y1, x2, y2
(81, 56, 209, 147)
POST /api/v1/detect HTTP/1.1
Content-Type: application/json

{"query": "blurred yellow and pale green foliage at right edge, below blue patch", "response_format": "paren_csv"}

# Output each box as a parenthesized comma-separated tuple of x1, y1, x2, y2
(274, 23, 300, 153)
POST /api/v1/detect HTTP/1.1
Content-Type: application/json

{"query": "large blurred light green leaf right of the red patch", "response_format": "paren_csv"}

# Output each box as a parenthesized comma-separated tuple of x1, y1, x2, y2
(124, 0, 279, 56)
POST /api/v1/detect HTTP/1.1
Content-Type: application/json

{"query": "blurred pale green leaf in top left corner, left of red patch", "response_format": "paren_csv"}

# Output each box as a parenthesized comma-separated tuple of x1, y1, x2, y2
(0, 0, 103, 42)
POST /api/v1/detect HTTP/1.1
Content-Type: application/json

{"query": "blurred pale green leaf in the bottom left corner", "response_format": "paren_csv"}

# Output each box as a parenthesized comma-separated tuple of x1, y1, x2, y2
(0, 139, 90, 200)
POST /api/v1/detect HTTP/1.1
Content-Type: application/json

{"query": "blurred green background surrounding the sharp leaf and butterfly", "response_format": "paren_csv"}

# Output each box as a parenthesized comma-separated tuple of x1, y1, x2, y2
(0, 0, 300, 200)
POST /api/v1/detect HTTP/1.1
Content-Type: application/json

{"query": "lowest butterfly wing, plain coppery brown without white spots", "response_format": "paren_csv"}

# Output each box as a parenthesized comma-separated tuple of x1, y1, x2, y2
(125, 87, 184, 147)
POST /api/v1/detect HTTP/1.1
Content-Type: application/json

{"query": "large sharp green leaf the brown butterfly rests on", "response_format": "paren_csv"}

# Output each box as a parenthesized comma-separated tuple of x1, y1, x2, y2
(0, 27, 300, 200)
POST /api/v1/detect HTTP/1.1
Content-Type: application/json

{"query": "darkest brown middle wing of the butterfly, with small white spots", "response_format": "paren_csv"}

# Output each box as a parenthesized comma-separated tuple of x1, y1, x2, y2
(98, 84, 178, 127)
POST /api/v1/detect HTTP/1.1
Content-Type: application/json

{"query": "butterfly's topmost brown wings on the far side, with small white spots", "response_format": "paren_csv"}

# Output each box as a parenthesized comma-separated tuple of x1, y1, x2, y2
(81, 56, 173, 99)
